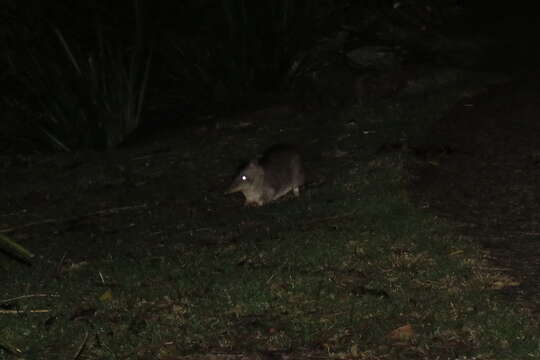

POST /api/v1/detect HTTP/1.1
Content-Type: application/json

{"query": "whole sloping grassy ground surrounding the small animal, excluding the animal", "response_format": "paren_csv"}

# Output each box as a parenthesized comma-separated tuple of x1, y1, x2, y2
(0, 69, 540, 360)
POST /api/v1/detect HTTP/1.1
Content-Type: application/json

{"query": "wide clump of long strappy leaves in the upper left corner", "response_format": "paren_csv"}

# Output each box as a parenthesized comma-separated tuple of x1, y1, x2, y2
(4, 0, 150, 151)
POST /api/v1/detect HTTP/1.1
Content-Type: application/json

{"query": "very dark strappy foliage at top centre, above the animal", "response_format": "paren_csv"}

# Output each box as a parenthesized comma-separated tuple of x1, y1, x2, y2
(166, 0, 348, 111)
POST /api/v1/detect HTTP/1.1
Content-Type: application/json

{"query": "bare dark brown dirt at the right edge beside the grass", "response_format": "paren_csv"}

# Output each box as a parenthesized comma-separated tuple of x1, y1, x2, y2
(411, 75, 540, 315)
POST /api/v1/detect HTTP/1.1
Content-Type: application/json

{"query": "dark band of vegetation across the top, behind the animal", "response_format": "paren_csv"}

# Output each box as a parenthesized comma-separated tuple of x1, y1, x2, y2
(1, 0, 476, 152)
